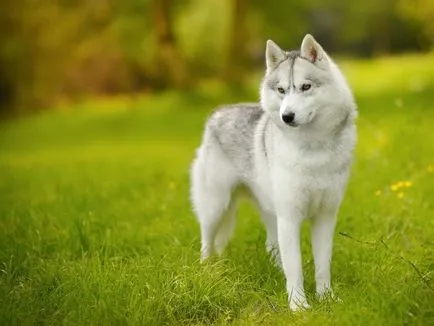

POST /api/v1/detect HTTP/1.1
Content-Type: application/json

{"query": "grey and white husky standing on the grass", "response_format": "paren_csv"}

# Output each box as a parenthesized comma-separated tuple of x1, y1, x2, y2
(191, 34, 357, 311)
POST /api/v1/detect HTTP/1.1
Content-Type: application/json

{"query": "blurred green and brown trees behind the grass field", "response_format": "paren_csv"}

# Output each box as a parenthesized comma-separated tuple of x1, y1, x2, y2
(0, 0, 434, 114)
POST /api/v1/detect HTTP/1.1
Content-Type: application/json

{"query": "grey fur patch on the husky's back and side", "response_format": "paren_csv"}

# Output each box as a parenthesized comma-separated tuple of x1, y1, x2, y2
(207, 103, 264, 174)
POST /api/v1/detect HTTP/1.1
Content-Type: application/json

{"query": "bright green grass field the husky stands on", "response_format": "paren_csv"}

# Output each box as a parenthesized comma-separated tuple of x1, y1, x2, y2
(0, 55, 434, 325)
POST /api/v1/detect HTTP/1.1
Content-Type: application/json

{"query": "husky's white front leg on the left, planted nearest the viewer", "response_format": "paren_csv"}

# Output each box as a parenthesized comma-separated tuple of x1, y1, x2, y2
(277, 212, 309, 311)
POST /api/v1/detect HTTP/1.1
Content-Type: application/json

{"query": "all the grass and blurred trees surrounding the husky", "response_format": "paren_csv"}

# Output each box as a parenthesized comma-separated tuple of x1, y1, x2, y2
(0, 0, 434, 325)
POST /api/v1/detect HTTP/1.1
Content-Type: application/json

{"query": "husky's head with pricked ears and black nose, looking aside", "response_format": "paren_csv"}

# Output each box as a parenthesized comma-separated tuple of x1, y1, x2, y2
(261, 34, 355, 129)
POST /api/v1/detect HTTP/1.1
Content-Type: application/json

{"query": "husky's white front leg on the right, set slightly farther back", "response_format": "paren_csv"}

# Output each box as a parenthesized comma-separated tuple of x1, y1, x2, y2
(311, 211, 336, 298)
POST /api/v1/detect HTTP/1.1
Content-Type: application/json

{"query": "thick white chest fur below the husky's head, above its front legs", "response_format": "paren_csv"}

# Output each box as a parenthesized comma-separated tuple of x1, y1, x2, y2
(270, 126, 355, 217)
